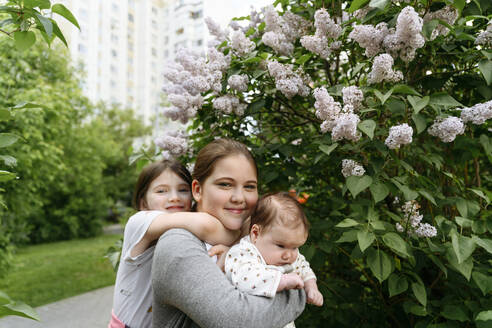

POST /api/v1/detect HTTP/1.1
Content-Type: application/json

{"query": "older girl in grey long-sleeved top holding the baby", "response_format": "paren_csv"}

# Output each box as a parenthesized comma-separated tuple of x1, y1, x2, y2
(152, 139, 306, 328)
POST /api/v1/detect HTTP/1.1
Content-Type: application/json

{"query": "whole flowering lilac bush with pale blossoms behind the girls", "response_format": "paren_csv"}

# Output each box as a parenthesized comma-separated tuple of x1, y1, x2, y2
(159, 0, 492, 327)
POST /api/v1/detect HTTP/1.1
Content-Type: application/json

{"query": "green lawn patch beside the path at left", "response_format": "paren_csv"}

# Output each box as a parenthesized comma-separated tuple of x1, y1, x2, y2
(0, 235, 121, 307)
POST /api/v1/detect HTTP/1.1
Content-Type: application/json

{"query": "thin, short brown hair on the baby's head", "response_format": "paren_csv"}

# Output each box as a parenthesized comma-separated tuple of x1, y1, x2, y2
(250, 192, 309, 233)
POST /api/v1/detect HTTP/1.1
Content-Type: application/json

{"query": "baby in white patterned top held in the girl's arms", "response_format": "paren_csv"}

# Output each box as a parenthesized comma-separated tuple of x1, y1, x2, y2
(225, 193, 323, 327)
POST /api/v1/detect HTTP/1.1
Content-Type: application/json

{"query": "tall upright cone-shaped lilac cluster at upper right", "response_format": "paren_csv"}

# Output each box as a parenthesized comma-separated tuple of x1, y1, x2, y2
(383, 6, 425, 62)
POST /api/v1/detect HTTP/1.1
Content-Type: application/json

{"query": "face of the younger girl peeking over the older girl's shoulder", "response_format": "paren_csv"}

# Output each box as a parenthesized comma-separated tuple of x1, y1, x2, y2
(141, 169, 191, 212)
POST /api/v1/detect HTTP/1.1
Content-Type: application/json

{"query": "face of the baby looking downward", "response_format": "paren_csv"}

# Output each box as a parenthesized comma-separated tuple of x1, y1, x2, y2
(250, 223, 307, 265)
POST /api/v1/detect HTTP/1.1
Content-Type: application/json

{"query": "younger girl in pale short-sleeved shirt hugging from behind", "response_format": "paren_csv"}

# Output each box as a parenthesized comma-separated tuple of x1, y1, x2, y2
(109, 161, 242, 328)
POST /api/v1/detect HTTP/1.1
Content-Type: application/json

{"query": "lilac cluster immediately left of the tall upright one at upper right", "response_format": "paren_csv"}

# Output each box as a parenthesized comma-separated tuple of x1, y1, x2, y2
(349, 22, 388, 57)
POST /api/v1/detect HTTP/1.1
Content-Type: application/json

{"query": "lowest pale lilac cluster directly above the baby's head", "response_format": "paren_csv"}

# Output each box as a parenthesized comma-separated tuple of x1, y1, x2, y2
(267, 61, 311, 99)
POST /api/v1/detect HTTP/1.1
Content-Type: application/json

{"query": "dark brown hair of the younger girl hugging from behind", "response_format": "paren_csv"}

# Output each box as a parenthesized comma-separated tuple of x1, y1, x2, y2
(133, 160, 191, 211)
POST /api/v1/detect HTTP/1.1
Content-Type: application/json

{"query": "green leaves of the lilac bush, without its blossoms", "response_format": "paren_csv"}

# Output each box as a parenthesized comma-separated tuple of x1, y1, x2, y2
(178, 0, 492, 327)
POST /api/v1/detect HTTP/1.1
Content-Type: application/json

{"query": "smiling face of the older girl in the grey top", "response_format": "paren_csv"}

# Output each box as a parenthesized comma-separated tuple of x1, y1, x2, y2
(192, 154, 258, 230)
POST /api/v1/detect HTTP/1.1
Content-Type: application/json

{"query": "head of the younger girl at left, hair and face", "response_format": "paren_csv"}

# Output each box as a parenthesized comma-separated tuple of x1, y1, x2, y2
(133, 160, 191, 212)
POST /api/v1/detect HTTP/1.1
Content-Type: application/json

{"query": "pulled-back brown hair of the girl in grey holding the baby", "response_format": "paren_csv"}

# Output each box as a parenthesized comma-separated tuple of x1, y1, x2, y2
(193, 139, 258, 184)
